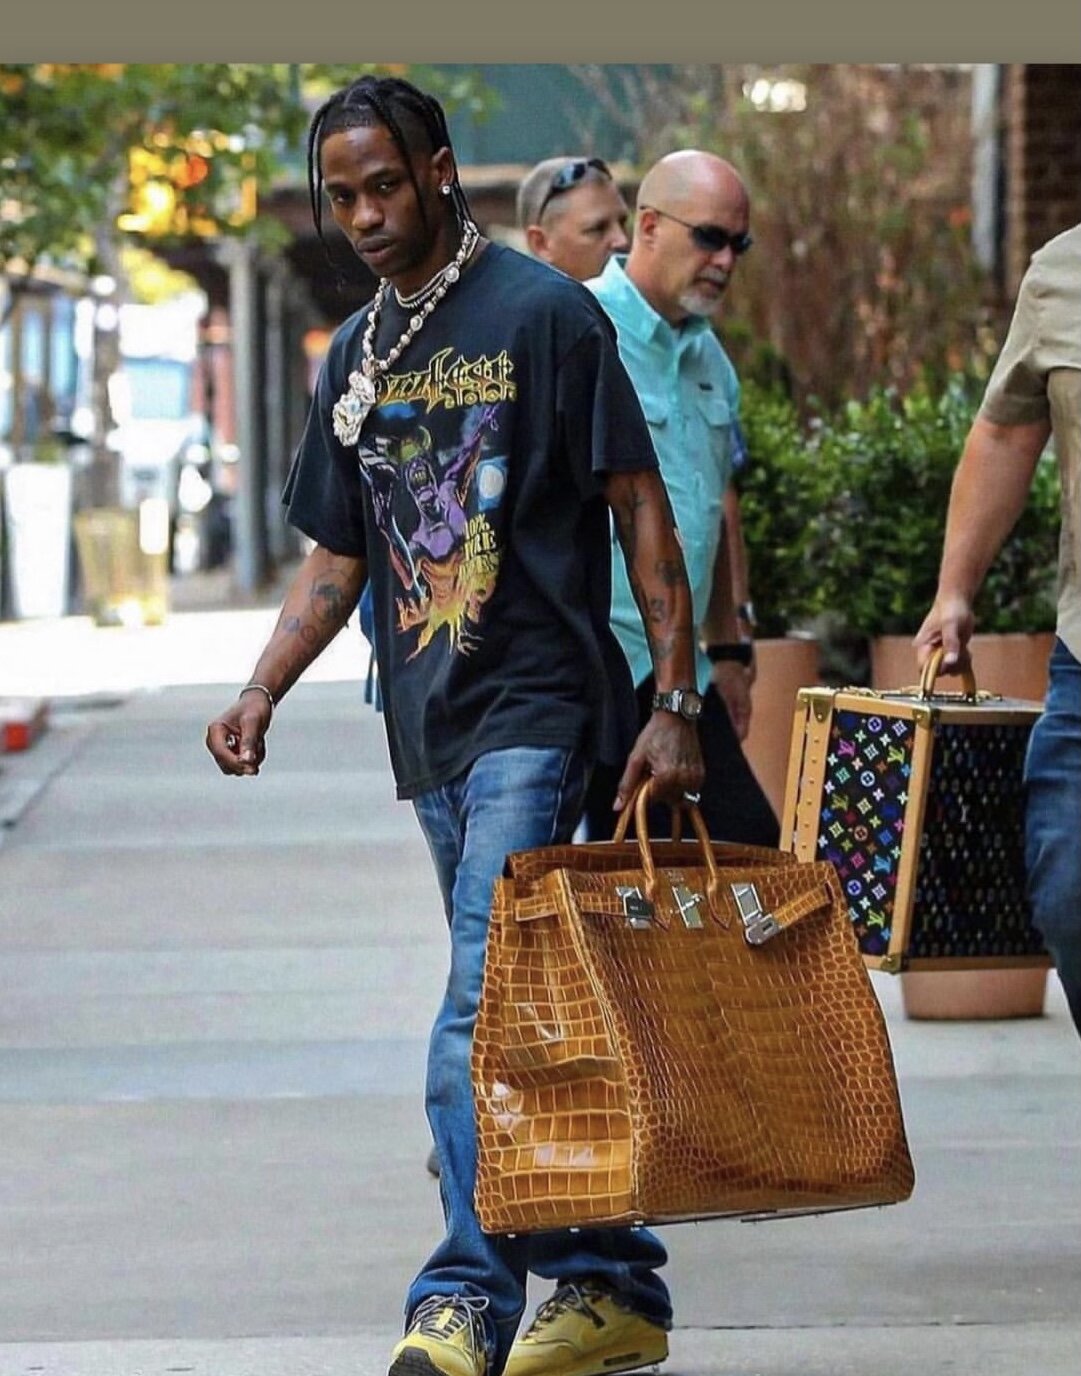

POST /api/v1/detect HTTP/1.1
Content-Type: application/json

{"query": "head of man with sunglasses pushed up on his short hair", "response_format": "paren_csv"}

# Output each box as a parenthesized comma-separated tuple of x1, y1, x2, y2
(517, 157, 630, 282)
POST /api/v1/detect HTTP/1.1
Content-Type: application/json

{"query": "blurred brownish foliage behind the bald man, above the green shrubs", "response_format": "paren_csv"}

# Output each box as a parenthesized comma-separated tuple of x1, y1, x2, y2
(569, 63, 1003, 406)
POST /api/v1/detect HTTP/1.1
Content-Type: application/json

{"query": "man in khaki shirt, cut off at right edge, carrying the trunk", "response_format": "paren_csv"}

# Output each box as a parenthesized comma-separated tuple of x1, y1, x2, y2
(916, 224, 1081, 1032)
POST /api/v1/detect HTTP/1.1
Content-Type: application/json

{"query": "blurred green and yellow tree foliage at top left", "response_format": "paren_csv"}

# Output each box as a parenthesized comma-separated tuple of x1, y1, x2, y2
(0, 62, 484, 282)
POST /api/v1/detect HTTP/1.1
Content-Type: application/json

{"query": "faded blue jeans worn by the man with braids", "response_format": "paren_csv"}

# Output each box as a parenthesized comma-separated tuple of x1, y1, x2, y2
(406, 746, 671, 1376)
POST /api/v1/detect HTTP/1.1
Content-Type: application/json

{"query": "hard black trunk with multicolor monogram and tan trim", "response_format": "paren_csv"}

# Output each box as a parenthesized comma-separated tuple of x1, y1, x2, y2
(781, 673, 1049, 973)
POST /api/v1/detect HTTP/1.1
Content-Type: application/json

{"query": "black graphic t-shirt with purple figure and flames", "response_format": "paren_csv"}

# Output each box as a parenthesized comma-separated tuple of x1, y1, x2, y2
(283, 244, 656, 798)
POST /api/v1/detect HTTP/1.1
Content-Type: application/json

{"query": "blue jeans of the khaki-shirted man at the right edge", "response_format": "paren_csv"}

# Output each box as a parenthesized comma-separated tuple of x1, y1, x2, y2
(1025, 640, 1081, 1032)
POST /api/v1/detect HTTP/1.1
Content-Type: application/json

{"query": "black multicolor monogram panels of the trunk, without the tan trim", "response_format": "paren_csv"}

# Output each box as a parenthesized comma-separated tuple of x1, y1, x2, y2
(817, 710, 1044, 962)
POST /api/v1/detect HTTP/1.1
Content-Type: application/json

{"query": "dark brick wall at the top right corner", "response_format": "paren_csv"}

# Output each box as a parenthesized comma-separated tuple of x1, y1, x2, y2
(1003, 63, 1081, 299)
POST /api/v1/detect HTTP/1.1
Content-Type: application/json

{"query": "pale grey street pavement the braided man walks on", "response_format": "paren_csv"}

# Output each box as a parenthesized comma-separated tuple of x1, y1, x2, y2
(0, 588, 1081, 1376)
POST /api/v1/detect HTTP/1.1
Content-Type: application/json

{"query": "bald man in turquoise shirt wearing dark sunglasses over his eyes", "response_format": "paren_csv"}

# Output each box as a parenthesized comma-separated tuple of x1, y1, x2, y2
(586, 150, 780, 846)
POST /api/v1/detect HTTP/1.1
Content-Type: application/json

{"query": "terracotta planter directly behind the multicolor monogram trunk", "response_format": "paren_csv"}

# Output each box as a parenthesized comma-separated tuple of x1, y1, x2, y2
(871, 632, 1055, 1021)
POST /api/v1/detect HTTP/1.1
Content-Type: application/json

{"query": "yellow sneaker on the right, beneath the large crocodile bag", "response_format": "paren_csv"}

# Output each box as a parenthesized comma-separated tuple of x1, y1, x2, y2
(503, 1281, 668, 1376)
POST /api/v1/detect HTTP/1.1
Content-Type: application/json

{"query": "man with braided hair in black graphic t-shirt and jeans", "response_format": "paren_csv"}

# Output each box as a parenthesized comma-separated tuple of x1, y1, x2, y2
(208, 77, 703, 1376)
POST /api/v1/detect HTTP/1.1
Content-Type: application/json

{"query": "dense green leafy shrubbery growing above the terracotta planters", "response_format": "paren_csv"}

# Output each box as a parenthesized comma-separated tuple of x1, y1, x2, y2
(740, 374, 1059, 637)
